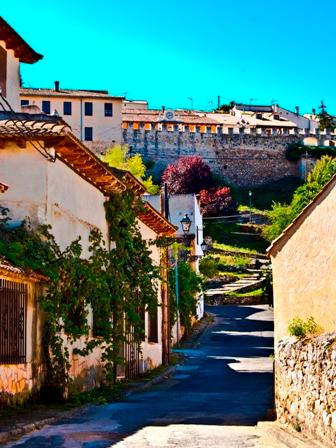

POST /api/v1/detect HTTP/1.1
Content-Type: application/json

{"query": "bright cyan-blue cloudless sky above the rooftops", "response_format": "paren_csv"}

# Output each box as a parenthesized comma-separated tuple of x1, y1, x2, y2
(0, 0, 336, 113)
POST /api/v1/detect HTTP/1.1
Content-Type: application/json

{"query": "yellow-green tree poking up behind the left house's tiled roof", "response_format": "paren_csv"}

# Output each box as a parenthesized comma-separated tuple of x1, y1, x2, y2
(103, 145, 159, 194)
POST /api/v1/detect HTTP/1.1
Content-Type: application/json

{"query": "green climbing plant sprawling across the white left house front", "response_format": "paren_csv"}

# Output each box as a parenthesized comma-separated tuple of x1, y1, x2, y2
(0, 192, 160, 390)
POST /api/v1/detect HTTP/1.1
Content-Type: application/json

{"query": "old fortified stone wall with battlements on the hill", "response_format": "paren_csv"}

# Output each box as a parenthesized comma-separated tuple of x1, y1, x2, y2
(123, 127, 304, 186)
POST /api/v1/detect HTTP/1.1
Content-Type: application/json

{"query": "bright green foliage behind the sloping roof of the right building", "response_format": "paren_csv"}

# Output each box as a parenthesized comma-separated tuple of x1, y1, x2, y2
(263, 156, 336, 241)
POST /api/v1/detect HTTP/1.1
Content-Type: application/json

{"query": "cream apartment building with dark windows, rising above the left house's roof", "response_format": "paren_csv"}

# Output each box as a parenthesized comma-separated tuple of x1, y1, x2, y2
(20, 81, 124, 154)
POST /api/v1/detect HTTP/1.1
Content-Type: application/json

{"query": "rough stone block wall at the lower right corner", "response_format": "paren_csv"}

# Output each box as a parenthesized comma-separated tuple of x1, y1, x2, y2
(275, 333, 336, 447)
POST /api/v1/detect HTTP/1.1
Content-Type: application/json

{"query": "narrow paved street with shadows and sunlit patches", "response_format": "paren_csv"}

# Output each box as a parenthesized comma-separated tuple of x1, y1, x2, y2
(6, 305, 273, 448)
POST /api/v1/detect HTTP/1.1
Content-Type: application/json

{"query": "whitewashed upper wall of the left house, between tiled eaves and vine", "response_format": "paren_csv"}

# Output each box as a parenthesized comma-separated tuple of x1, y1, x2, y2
(0, 143, 107, 256)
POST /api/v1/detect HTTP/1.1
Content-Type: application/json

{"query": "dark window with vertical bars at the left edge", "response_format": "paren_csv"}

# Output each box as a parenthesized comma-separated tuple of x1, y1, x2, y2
(0, 279, 28, 364)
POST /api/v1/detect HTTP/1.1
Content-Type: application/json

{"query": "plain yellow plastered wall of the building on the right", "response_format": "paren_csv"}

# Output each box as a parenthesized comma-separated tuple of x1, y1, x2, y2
(271, 182, 336, 342)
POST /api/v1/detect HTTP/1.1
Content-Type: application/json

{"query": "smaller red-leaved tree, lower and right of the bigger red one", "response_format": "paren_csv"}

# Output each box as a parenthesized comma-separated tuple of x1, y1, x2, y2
(200, 187, 237, 216)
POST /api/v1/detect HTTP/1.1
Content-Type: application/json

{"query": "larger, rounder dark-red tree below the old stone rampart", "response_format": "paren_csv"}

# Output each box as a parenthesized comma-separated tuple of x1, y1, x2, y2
(162, 156, 213, 194)
